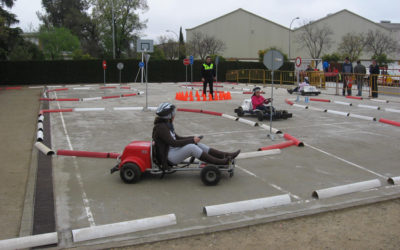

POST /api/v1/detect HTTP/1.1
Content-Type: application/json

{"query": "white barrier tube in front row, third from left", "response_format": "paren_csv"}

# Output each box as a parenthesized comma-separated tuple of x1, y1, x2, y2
(203, 194, 291, 216)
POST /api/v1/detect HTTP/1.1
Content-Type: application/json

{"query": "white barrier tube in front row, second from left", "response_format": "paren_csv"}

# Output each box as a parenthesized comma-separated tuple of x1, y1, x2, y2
(72, 214, 176, 242)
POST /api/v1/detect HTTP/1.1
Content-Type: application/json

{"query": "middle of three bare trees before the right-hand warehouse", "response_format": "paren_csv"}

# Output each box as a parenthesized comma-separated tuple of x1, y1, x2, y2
(338, 33, 365, 62)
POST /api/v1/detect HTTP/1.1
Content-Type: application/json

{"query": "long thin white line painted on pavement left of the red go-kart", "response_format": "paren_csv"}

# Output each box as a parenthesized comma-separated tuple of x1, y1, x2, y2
(55, 93, 96, 227)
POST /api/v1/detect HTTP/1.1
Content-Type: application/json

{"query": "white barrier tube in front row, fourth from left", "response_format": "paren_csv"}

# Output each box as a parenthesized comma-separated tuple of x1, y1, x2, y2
(312, 179, 381, 199)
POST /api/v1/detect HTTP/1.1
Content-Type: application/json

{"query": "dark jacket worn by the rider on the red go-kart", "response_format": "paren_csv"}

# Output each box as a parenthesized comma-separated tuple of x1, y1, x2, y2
(152, 118, 194, 169)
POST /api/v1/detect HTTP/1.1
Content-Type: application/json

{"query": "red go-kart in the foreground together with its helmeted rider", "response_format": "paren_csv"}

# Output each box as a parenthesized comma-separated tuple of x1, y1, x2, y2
(111, 103, 240, 186)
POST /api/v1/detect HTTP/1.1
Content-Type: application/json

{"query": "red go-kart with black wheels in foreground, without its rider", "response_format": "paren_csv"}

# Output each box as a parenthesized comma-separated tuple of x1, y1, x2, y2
(111, 141, 235, 186)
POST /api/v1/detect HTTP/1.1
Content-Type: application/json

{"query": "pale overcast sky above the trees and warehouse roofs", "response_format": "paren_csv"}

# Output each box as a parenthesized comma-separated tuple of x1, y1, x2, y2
(11, 0, 400, 39)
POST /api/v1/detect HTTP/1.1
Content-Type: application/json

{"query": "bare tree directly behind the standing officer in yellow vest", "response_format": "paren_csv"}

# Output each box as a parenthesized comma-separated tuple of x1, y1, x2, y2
(187, 32, 226, 60)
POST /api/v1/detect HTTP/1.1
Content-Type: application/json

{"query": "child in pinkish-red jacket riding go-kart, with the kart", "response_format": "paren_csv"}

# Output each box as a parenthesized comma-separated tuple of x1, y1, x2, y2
(234, 87, 292, 121)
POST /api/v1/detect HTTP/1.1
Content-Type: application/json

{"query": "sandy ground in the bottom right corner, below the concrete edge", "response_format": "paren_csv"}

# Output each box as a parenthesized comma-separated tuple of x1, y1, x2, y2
(120, 199, 400, 250)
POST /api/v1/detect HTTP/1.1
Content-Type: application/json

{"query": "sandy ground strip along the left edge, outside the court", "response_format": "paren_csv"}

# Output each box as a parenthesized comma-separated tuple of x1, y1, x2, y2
(0, 88, 40, 239)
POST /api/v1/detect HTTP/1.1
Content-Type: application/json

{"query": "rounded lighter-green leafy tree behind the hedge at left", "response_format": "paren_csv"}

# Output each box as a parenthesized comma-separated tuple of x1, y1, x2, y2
(39, 27, 80, 60)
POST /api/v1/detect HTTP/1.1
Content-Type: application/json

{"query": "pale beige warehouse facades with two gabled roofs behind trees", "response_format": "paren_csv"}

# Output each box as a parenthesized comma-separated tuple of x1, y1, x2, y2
(186, 9, 400, 60)
